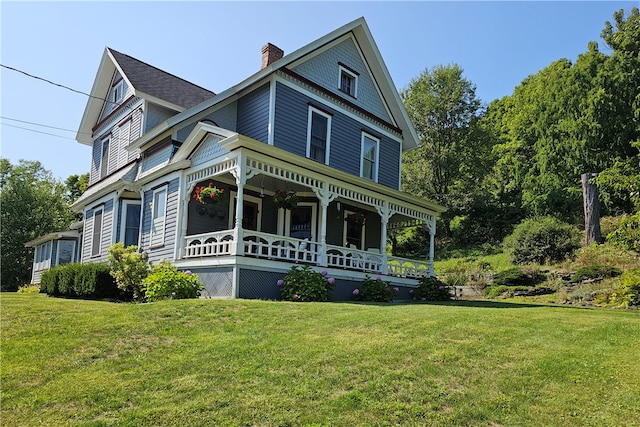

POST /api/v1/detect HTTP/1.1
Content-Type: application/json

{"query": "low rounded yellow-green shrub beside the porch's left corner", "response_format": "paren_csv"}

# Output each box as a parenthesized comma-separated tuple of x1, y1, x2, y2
(142, 260, 204, 301)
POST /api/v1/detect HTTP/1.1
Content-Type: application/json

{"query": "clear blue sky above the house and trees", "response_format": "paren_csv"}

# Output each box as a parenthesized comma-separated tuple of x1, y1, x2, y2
(0, 0, 637, 179)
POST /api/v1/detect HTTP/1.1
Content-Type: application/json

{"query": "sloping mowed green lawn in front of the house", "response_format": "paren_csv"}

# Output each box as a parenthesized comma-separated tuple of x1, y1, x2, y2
(0, 294, 640, 426)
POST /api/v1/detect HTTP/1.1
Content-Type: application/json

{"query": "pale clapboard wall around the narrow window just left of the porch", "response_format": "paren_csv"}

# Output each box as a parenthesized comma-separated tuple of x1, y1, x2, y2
(140, 178, 180, 263)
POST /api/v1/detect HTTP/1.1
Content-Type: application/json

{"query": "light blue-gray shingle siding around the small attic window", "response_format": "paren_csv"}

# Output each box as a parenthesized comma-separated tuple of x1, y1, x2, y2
(293, 39, 391, 121)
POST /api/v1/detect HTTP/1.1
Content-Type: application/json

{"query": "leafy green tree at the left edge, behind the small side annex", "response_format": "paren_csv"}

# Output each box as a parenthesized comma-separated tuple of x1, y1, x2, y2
(0, 159, 73, 291)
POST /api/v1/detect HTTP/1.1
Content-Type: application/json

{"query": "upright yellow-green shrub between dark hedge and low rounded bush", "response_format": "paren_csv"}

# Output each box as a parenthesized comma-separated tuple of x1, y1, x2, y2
(107, 242, 149, 301)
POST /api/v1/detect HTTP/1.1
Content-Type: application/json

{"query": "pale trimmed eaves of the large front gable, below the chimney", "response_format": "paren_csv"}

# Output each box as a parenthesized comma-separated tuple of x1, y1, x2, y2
(129, 17, 420, 154)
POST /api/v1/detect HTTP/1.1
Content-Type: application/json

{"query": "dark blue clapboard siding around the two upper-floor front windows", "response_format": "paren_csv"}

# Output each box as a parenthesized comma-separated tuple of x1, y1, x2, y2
(274, 83, 400, 189)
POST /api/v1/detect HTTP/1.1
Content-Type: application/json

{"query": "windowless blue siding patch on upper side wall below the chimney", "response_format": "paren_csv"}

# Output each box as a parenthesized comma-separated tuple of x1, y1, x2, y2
(237, 84, 269, 142)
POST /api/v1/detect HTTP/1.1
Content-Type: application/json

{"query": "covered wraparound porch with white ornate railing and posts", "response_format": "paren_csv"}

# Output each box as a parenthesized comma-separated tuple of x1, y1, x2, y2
(176, 124, 444, 284)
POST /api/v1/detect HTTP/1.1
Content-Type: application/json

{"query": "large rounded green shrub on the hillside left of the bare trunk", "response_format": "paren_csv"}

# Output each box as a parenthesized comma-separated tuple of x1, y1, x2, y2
(503, 217, 581, 264)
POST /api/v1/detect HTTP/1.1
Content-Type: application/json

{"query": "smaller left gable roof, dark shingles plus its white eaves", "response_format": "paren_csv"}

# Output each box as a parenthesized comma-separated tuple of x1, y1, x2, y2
(76, 47, 215, 145)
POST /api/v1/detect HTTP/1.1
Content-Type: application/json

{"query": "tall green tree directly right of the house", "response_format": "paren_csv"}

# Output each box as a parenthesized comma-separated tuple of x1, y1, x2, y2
(400, 64, 490, 237)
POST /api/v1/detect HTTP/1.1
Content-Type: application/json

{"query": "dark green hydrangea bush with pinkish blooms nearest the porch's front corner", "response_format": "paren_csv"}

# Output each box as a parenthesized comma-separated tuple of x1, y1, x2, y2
(277, 265, 335, 302)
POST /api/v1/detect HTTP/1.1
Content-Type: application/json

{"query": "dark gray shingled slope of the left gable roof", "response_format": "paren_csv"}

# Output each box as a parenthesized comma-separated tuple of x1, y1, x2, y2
(107, 48, 215, 108)
